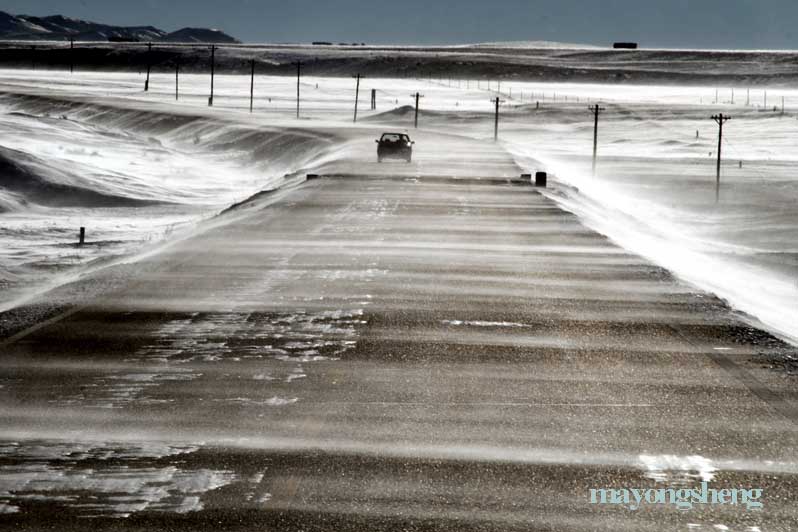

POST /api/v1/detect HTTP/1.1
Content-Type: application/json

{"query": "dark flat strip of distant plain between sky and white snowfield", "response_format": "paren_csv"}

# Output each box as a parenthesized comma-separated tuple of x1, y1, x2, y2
(0, 41, 798, 88)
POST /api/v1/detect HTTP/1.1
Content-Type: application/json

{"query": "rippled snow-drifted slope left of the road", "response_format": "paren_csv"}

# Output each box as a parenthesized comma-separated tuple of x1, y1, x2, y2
(0, 93, 350, 309)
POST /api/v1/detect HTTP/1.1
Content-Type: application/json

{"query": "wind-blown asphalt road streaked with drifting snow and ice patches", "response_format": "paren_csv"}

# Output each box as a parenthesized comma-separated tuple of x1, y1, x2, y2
(0, 137, 798, 531)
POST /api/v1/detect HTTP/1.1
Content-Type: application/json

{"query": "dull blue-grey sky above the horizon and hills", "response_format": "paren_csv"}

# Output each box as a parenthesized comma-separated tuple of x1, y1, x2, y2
(0, 0, 798, 49)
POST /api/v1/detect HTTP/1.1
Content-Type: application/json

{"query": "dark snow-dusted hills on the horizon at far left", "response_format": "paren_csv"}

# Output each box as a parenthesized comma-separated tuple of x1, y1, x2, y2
(0, 11, 239, 43)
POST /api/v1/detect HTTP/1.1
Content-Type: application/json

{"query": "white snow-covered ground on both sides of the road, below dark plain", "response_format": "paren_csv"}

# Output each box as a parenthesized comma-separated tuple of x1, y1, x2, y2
(0, 70, 798, 341)
